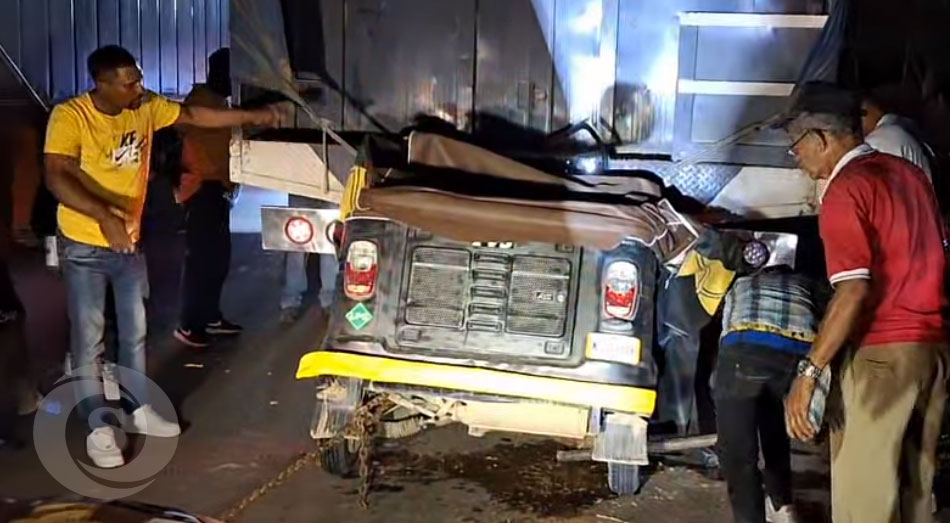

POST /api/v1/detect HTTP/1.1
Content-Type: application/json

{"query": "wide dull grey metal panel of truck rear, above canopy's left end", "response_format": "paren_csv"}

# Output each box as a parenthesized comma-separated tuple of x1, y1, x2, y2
(344, 0, 475, 130)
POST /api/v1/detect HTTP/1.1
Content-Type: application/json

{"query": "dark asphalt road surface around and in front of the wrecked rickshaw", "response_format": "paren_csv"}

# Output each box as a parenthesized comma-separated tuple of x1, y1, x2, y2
(0, 235, 940, 523)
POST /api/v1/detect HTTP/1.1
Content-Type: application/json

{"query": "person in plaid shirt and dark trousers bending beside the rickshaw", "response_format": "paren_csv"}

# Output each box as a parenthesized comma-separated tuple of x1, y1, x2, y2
(715, 268, 825, 523)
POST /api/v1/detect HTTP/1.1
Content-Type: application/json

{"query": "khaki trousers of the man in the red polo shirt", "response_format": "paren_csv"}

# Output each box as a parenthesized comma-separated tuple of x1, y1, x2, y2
(831, 343, 950, 523)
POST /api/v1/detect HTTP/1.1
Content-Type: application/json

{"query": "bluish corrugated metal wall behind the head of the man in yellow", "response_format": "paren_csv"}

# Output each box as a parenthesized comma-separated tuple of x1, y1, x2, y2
(0, 0, 229, 102)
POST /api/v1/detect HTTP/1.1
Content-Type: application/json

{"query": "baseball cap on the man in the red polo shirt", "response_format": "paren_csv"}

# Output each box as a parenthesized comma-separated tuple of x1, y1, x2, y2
(774, 82, 861, 134)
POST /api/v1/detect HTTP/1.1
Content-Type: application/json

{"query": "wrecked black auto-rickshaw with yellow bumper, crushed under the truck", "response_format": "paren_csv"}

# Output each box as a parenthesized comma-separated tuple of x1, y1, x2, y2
(297, 131, 795, 493)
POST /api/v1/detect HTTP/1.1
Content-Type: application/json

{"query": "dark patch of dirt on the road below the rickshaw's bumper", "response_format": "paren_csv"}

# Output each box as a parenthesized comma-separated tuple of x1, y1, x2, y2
(378, 442, 616, 517)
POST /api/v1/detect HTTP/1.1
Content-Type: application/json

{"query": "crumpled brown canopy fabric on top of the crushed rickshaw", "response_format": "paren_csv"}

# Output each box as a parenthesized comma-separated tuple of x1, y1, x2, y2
(348, 133, 699, 260)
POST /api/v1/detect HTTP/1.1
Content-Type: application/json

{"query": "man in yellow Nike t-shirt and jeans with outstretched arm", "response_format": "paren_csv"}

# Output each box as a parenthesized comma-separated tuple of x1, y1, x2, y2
(44, 45, 279, 468)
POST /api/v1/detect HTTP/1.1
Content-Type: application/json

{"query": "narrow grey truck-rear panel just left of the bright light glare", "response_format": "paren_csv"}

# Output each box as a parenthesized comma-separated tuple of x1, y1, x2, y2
(475, 0, 555, 132)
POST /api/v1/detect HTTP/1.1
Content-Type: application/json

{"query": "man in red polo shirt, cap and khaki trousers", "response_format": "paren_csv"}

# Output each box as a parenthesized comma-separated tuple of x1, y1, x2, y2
(786, 83, 950, 523)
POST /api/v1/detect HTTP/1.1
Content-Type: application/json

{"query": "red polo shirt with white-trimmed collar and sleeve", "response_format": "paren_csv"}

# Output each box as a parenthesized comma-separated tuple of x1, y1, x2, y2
(819, 149, 947, 345)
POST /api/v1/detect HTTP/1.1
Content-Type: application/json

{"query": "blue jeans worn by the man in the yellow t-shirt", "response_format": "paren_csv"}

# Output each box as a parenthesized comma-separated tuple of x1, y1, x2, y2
(62, 238, 149, 429)
